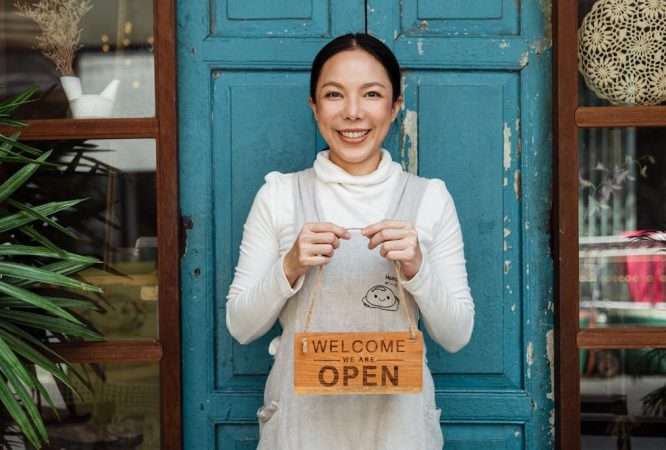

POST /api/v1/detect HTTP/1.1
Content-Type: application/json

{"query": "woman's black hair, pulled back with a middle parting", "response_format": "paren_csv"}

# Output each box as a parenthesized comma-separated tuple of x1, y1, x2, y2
(310, 33, 400, 103)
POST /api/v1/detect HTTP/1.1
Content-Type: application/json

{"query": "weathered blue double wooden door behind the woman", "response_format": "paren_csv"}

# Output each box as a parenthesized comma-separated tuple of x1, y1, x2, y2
(178, 0, 553, 449)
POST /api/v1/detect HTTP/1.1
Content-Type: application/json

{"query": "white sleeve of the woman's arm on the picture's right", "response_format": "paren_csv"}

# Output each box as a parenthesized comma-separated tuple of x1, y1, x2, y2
(403, 180, 474, 352)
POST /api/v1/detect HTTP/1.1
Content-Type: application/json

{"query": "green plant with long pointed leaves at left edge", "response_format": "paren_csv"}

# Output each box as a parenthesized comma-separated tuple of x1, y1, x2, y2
(0, 88, 103, 448)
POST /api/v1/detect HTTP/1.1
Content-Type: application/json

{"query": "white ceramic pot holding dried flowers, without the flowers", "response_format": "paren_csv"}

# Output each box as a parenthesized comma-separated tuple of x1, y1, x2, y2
(60, 77, 120, 119)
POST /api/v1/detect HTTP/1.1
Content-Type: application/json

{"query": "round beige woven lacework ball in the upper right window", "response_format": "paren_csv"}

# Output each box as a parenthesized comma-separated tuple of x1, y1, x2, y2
(578, 0, 666, 105)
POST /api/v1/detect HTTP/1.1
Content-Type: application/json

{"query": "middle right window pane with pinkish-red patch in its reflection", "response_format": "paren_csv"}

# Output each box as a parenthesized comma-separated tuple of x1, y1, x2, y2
(578, 128, 666, 327)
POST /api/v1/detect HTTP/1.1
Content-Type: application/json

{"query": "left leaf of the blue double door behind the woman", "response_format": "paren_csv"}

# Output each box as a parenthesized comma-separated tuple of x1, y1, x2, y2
(178, 0, 365, 449)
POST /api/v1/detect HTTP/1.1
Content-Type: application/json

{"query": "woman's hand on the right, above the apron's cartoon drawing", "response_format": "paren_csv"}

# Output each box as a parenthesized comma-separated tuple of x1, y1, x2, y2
(361, 220, 423, 280)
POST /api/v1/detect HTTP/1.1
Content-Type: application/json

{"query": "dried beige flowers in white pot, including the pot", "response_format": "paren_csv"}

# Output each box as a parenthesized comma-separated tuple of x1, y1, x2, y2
(15, 0, 120, 118)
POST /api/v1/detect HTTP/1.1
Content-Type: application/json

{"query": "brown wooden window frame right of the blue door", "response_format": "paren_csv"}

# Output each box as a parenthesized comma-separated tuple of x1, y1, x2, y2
(552, 0, 666, 450)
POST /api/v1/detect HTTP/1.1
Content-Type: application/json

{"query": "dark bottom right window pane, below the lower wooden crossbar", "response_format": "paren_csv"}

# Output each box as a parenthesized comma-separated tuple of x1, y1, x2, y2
(580, 349, 666, 450)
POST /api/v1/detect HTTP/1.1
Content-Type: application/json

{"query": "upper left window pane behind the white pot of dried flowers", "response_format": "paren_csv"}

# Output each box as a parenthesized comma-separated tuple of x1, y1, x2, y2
(0, 0, 155, 119)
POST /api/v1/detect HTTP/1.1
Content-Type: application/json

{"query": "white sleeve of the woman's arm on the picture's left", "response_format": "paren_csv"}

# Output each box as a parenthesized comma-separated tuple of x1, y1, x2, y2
(226, 173, 304, 344)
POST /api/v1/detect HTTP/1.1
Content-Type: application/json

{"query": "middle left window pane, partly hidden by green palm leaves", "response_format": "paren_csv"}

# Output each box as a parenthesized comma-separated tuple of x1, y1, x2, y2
(20, 139, 158, 339)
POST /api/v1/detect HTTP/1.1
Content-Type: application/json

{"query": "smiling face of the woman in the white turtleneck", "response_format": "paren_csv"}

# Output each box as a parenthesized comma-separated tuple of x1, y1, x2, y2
(309, 49, 402, 175)
